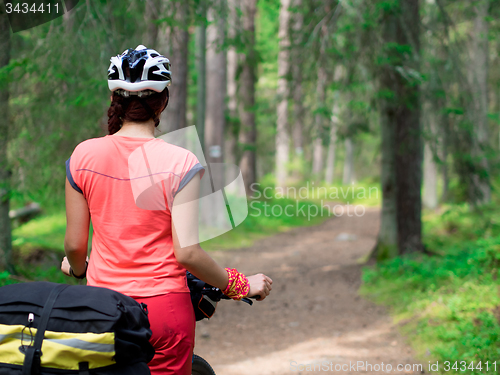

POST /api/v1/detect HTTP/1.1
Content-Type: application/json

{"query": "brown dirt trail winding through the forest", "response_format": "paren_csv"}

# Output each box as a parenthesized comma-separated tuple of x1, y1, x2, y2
(195, 209, 426, 375)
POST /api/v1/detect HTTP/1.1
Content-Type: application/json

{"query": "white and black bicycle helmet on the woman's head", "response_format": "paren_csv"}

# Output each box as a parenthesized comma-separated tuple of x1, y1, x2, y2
(108, 44, 172, 97)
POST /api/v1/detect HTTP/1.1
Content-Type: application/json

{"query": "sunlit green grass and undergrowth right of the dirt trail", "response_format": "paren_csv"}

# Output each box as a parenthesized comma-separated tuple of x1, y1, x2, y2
(361, 206, 500, 374)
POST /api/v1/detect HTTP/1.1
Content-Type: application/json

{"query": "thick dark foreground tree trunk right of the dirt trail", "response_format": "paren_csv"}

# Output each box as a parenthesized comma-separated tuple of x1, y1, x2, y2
(394, 0, 424, 254)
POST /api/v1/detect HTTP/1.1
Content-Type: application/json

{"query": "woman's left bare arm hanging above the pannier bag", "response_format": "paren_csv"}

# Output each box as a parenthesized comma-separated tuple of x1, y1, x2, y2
(61, 179, 90, 276)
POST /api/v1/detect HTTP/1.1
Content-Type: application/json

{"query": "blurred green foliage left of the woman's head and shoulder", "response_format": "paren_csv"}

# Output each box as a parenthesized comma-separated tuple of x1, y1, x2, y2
(6, 1, 159, 209)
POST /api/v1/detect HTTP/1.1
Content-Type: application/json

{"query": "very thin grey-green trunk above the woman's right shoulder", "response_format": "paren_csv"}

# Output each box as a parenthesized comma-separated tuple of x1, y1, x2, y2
(196, 2, 207, 154)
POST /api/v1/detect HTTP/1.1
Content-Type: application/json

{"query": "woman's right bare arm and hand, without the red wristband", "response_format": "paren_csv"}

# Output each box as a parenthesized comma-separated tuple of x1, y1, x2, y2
(172, 174, 272, 300)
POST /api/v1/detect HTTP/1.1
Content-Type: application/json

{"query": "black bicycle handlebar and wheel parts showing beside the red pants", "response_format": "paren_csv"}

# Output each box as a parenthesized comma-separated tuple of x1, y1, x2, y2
(186, 272, 258, 375)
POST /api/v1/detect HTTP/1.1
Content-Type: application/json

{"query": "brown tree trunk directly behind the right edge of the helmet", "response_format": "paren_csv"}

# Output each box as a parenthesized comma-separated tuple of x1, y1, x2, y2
(160, 0, 189, 132)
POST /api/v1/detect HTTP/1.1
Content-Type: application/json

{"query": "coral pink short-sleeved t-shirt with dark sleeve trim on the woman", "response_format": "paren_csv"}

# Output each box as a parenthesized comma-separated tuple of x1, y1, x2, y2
(66, 135, 204, 297)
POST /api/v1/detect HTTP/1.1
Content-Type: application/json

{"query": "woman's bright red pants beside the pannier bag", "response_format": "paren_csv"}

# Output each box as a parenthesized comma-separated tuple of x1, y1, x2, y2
(134, 293, 196, 375)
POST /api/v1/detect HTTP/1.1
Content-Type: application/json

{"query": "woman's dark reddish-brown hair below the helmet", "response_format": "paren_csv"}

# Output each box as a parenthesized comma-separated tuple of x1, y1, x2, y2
(108, 88, 168, 135)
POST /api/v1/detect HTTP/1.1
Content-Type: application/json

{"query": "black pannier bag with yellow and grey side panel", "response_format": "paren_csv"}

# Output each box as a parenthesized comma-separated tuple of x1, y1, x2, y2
(0, 282, 154, 375)
